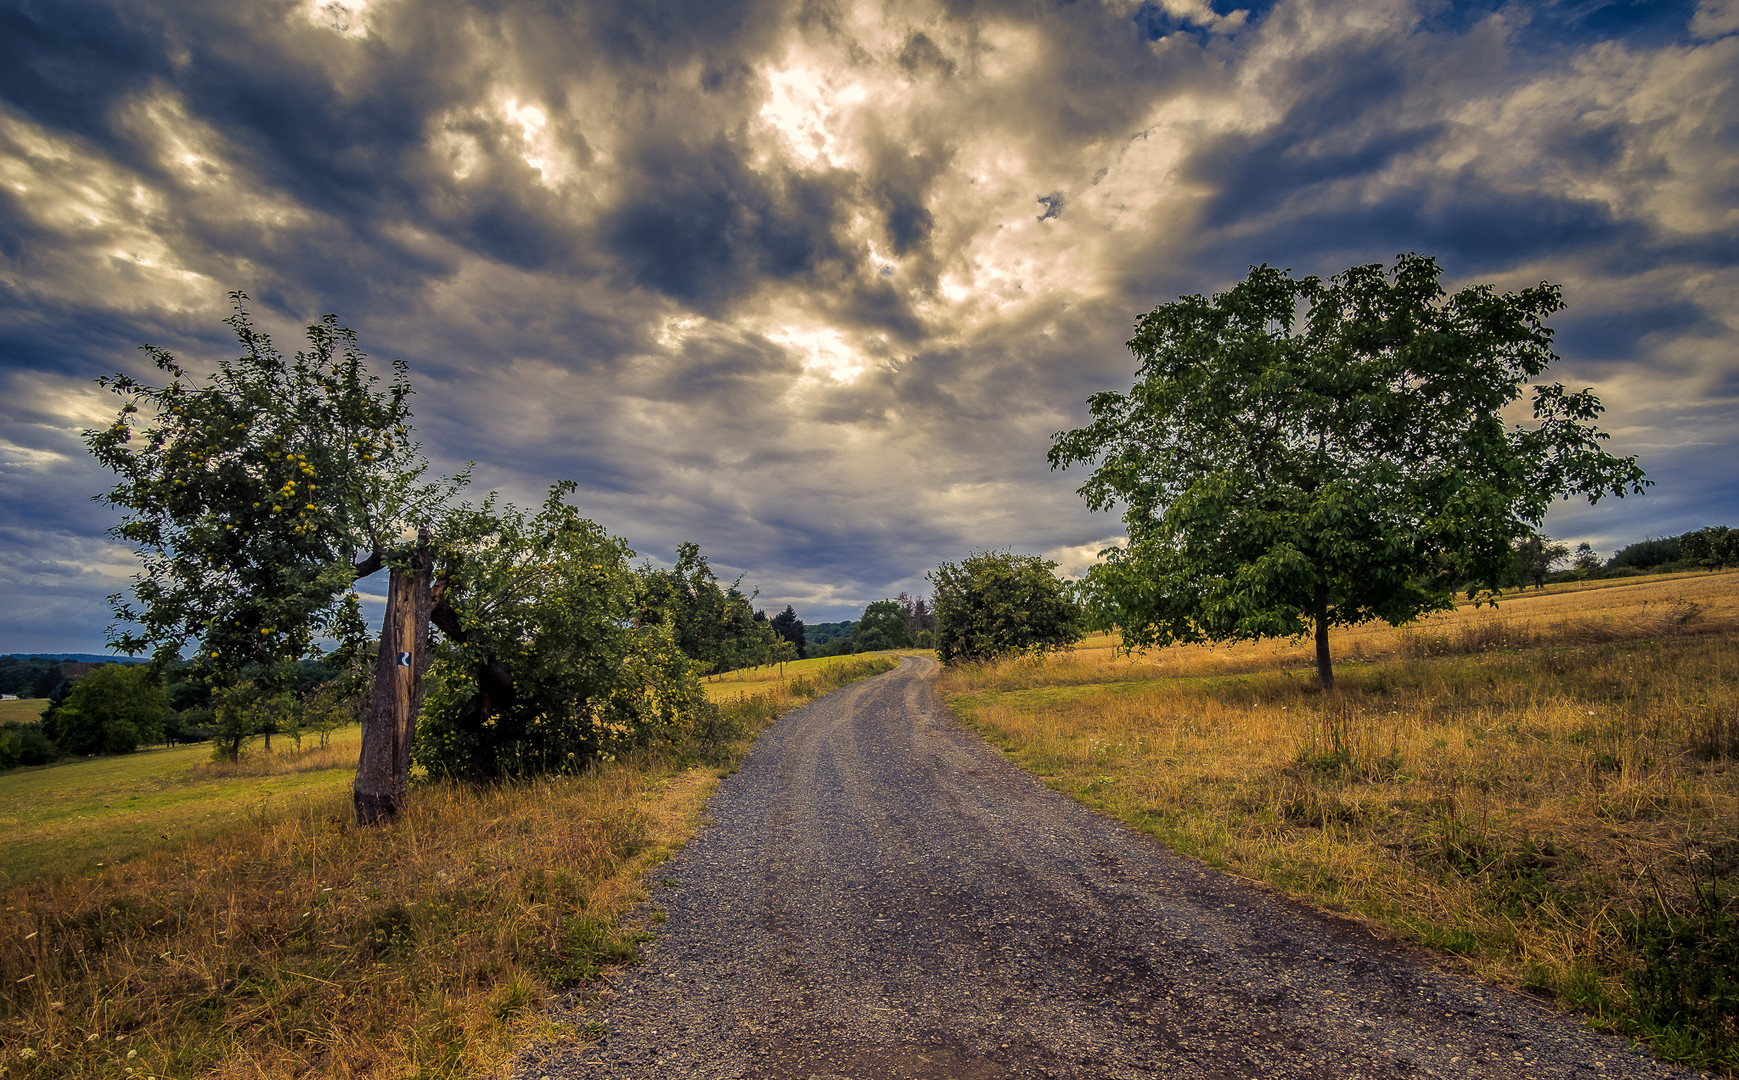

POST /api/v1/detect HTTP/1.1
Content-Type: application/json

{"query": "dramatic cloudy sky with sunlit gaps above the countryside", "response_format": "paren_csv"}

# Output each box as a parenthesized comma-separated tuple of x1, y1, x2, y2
(0, 0, 1739, 650)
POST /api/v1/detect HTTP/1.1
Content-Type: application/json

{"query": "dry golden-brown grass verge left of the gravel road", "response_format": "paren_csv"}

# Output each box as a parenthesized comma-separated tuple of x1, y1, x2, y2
(0, 646, 896, 1080)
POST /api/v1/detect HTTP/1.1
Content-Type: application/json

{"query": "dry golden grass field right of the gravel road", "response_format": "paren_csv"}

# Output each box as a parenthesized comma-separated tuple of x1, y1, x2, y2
(939, 572, 1739, 1075)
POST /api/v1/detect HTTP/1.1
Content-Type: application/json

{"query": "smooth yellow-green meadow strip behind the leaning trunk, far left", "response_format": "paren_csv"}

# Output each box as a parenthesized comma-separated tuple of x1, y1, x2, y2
(0, 723, 360, 885)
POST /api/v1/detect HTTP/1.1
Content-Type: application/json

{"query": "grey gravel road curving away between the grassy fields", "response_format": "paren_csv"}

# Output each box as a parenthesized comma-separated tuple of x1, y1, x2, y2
(518, 659, 1702, 1080)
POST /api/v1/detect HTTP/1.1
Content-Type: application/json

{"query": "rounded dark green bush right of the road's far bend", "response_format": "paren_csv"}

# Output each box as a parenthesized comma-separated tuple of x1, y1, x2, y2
(927, 551, 1083, 664)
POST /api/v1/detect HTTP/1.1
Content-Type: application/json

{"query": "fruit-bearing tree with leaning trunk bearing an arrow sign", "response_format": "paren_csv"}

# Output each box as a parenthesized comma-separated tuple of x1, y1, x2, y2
(85, 292, 464, 823)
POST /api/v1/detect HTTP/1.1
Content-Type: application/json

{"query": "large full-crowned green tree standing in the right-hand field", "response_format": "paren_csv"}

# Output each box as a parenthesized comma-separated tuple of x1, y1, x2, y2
(1049, 256, 1649, 689)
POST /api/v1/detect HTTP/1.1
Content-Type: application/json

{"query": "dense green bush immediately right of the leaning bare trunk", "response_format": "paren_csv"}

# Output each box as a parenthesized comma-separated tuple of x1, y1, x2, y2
(414, 483, 706, 779)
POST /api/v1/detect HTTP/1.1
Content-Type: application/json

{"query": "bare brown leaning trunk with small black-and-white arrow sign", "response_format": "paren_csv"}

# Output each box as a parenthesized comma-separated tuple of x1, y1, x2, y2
(351, 536, 435, 824)
